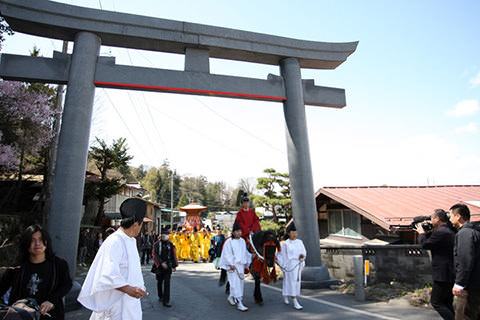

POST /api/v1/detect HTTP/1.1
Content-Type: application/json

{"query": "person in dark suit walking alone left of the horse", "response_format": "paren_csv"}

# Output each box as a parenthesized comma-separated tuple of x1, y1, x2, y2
(153, 229, 178, 308)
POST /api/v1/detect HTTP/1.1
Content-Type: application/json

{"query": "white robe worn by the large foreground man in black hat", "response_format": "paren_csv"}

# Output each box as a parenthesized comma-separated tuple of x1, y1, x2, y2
(78, 229, 145, 320)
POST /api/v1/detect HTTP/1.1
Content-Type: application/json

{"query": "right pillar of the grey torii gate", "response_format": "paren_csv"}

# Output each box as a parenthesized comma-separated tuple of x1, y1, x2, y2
(280, 58, 337, 288)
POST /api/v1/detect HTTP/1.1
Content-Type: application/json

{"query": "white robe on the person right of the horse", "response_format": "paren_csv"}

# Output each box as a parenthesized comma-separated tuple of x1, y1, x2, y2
(277, 239, 307, 297)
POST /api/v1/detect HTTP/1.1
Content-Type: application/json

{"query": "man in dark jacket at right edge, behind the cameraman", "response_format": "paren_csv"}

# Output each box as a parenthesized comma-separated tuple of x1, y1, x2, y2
(450, 203, 480, 320)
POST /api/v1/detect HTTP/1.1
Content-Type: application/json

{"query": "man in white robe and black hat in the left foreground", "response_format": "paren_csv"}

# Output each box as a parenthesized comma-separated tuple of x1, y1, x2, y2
(78, 198, 152, 320)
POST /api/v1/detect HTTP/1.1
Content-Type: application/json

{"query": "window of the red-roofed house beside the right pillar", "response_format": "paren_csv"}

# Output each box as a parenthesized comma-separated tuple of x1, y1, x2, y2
(328, 209, 362, 238)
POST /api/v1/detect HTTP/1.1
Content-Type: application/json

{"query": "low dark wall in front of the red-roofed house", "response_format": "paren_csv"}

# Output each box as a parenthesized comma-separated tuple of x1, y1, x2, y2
(322, 245, 432, 284)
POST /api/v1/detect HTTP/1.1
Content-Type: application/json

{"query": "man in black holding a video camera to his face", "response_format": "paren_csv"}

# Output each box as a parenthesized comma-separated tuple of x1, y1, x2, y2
(417, 209, 455, 320)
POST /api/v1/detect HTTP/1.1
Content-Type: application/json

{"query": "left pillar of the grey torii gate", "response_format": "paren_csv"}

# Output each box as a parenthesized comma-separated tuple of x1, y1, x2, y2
(48, 32, 100, 279)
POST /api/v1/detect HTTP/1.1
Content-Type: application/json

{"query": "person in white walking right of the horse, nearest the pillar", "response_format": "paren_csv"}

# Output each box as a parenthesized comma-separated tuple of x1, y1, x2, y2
(277, 222, 307, 310)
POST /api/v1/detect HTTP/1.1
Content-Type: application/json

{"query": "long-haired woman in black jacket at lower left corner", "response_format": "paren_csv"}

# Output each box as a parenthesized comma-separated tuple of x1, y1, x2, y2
(0, 225, 72, 320)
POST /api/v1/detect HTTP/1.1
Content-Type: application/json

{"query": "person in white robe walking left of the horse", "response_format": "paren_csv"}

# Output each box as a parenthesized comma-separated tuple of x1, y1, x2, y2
(219, 223, 252, 311)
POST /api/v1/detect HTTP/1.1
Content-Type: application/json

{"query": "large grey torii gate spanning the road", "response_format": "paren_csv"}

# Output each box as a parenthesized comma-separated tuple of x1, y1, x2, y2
(0, 0, 358, 287)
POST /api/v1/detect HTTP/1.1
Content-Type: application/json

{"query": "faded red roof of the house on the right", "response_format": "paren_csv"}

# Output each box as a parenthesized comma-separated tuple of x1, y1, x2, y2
(315, 185, 480, 229)
